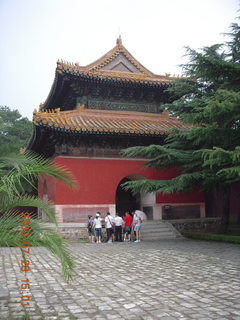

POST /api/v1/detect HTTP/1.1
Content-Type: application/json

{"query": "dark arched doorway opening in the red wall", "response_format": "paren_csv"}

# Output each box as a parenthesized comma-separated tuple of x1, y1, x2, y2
(116, 178, 140, 216)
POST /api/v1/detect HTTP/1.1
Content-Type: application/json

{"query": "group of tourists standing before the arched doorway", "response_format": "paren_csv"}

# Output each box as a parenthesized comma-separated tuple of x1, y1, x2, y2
(87, 211, 143, 243)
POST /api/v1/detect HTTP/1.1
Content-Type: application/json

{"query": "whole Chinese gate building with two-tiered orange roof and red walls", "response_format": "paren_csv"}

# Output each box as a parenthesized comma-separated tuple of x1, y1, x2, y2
(28, 37, 205, 223)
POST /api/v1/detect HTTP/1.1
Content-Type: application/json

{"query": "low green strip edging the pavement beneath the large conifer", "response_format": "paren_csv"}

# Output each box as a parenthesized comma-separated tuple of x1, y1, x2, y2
(183, 232, 240, 244)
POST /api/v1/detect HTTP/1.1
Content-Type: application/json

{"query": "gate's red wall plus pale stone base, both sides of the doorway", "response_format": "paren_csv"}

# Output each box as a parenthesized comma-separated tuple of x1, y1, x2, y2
(39, 156, 203, 222)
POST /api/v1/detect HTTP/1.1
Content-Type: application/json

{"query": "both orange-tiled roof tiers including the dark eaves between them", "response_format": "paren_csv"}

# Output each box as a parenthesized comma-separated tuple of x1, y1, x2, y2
(28, 37, 187, 156)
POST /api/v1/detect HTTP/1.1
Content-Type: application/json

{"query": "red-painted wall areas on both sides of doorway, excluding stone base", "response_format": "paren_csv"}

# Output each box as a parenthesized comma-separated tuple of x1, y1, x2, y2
(45, 156, 203, 205)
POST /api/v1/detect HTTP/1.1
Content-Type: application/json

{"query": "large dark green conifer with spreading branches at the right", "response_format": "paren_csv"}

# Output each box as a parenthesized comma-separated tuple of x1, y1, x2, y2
(123, 20, 240, 232)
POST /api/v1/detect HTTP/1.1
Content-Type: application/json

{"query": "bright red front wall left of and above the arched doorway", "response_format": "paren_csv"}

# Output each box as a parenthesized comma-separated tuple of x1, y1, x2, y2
(55, 157, 154, 204)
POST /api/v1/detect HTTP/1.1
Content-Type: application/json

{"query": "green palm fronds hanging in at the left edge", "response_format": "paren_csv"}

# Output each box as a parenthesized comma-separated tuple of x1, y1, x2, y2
(0, 152, 74, 280)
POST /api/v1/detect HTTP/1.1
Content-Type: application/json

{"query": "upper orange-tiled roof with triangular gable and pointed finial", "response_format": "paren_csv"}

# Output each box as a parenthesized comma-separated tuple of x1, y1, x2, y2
(40, 37, 179, 110)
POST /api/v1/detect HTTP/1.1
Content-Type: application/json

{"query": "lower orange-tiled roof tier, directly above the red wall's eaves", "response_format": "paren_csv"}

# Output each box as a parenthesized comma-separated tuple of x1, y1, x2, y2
(33, 106, 187, 135)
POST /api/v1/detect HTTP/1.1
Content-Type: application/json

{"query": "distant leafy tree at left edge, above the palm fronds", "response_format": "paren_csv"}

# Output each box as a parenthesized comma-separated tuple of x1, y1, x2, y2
(0, 106, 32, 154)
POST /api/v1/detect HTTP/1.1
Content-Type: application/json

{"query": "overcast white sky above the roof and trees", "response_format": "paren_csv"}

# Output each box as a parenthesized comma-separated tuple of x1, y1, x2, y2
(0, 0, 240, 119)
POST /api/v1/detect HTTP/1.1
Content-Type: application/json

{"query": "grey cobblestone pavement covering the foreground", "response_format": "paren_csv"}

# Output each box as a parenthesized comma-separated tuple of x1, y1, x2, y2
(0, 239, 240, 320)
